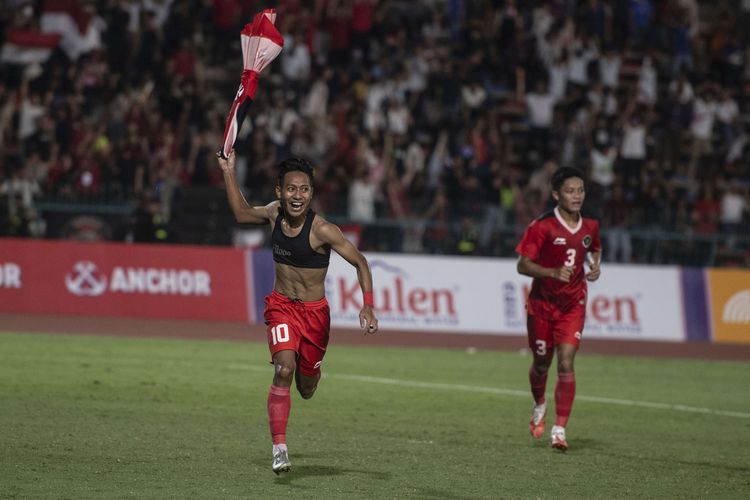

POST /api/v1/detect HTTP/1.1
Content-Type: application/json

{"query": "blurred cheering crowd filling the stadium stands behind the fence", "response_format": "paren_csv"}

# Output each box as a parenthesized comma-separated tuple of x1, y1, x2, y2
(0, 0, 750, 265)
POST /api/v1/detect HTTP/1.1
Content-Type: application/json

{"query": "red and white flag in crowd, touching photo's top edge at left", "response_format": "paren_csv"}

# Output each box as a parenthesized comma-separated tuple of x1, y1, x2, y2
(39, 0, 102, 61)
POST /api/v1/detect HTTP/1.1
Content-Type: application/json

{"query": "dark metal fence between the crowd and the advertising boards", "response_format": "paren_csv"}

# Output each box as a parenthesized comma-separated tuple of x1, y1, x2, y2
(30, 194, 750, 267)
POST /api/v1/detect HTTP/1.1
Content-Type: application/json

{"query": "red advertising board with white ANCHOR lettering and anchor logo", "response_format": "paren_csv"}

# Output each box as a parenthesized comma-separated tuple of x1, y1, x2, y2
(0, 239, 253, 321)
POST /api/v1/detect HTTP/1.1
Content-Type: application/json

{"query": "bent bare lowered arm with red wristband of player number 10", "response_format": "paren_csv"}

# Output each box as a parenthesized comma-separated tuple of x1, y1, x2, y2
(316, 222, 378, 334)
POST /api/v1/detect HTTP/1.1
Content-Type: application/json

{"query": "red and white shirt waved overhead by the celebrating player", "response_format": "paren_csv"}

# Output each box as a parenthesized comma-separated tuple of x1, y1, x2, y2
(222, 9, 284, 158)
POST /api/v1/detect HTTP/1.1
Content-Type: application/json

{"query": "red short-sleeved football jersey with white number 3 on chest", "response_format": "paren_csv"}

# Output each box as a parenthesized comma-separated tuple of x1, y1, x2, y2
(516, 208, 602, 314)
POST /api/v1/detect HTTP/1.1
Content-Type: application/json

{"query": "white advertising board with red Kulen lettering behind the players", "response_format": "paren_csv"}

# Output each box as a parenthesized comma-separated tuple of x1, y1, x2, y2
(326, 253, 685, 341)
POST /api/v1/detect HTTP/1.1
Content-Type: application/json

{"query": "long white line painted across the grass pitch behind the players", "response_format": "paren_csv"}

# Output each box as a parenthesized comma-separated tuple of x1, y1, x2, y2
(229, 364, 750, 418)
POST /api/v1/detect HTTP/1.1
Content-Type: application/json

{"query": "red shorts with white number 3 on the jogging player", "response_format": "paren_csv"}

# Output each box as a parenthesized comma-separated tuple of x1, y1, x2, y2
(526, 303, 586, 357)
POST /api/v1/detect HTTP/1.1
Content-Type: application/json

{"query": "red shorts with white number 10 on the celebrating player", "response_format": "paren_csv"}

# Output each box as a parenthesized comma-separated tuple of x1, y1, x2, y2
(263, 290, 331, 377)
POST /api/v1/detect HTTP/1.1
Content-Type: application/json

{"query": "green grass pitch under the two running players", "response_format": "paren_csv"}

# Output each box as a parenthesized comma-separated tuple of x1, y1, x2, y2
(0, 333, 750, 499)
